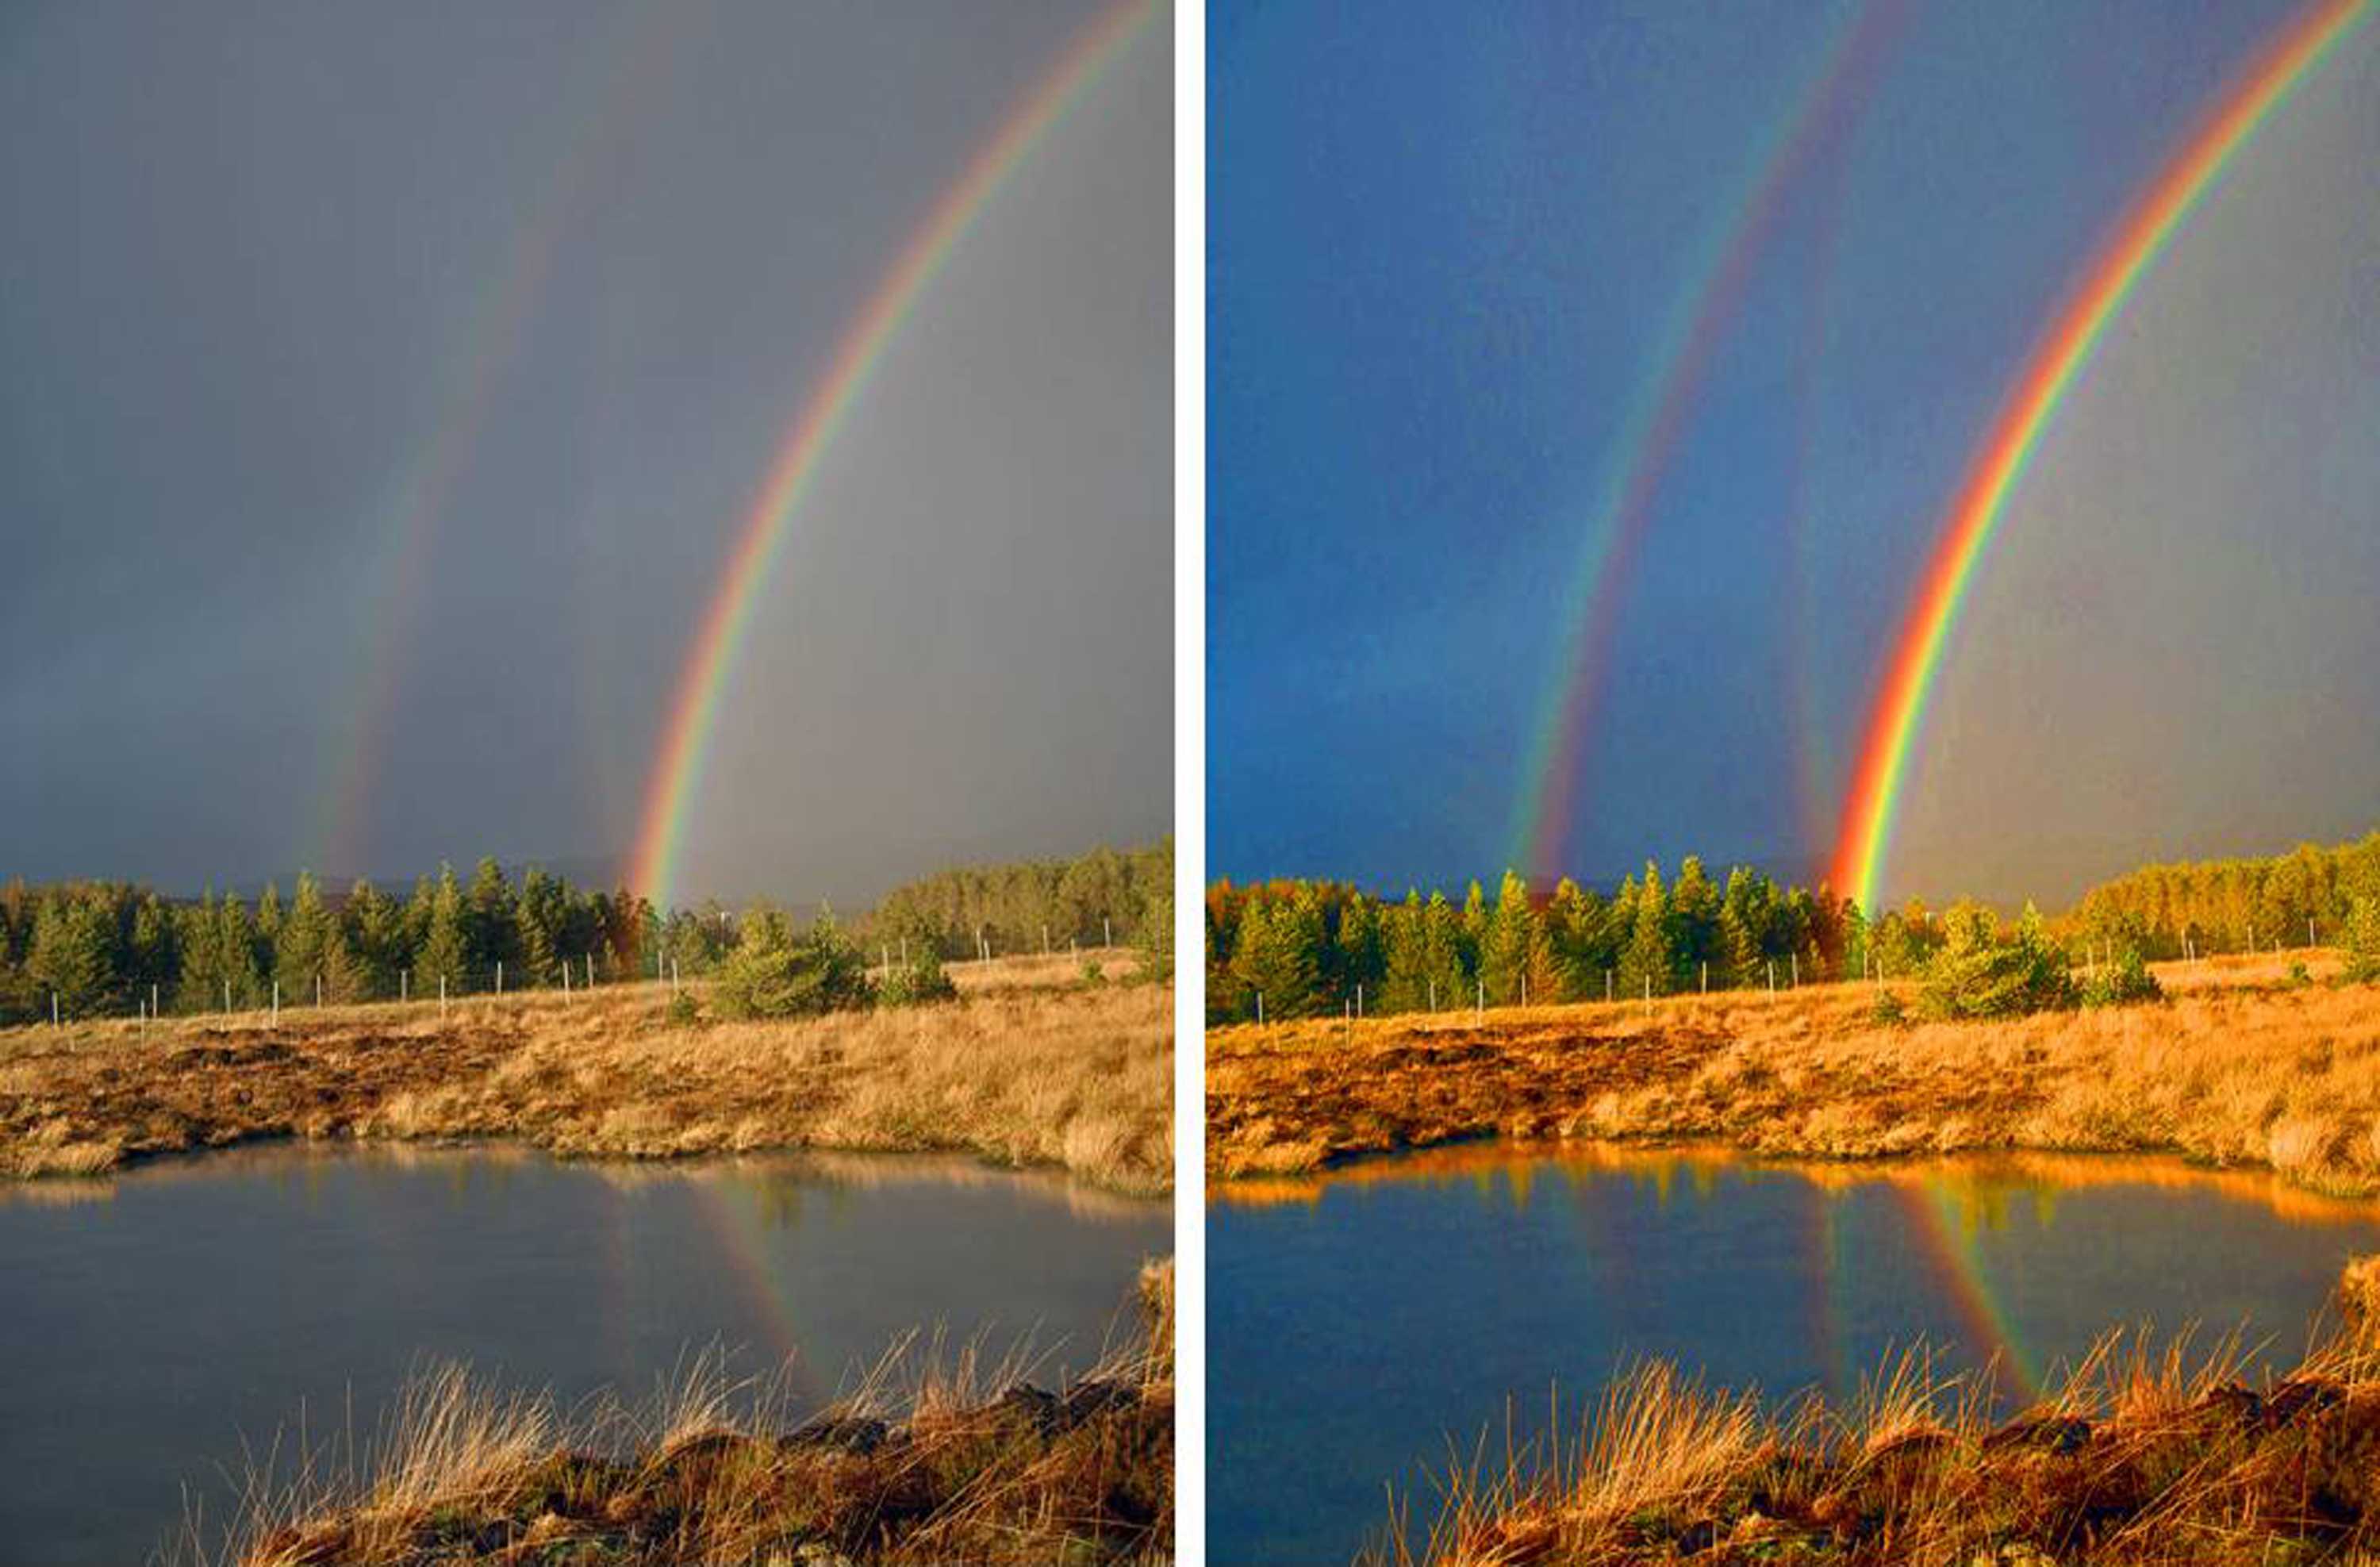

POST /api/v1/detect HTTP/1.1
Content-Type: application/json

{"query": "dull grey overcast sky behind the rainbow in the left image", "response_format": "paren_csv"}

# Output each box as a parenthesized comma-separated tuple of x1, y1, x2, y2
(0, 0, 1173, 903)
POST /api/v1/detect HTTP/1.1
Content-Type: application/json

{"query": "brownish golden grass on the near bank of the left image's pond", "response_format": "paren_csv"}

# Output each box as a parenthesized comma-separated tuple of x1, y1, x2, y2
(202, 1262, 1173, 1567)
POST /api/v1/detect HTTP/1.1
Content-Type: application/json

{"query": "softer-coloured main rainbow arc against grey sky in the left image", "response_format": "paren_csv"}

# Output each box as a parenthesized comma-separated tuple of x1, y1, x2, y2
(628, 0, 1157, 908)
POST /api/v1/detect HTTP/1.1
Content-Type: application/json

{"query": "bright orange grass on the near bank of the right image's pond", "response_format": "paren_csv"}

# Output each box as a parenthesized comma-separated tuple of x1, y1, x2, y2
(1364, 1334, 2380, 1567)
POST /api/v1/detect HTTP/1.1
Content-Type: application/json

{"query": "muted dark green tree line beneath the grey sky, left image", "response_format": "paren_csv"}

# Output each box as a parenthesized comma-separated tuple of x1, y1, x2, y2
(0, 841, 1173, 1024)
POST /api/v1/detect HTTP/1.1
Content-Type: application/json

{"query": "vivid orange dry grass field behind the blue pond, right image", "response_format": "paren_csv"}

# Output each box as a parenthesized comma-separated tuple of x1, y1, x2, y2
(1207, 951, 2380, 1196)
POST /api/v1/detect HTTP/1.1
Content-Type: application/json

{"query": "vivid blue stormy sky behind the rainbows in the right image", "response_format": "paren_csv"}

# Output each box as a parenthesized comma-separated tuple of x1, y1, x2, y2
(1207, 0, 2380, 908)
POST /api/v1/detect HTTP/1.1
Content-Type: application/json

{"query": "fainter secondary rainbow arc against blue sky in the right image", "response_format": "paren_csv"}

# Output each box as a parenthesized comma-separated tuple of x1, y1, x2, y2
(1511, 0, 1906, 874)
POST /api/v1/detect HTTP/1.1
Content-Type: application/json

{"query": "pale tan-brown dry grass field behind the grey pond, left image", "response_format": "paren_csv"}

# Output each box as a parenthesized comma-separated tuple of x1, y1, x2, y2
(0, 951, 1173, 1193)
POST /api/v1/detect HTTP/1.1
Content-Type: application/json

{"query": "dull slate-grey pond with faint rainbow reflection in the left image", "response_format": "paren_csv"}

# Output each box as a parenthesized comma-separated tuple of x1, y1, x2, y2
(0, 1146, 1173, 1567)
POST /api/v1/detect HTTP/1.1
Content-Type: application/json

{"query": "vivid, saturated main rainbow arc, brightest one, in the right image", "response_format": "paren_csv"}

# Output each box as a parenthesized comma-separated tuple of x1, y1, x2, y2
(1833, 0, 2370, 910)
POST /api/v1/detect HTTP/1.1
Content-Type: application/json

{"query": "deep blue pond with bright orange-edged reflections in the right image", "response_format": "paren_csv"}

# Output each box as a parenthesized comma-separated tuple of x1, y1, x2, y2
(1207, 1146, 2380, 1562)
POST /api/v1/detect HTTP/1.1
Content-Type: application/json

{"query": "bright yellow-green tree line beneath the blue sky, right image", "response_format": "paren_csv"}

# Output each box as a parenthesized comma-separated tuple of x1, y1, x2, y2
(1207, 832, 2380, 1024)
